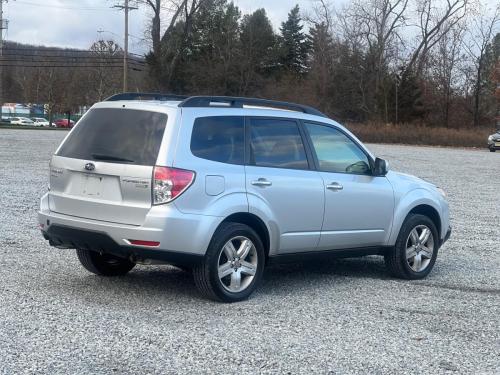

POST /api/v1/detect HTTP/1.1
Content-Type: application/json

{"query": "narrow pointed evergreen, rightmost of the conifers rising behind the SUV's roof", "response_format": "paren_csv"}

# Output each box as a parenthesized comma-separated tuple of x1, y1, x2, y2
(280, 5, 310, 73)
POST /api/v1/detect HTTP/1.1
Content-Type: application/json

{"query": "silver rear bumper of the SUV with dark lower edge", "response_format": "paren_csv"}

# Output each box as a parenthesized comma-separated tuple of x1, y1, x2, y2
(38, 194, 223, 259)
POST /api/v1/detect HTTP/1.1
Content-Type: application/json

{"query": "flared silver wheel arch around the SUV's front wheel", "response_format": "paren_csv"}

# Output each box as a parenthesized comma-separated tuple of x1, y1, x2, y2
(387, 188, 449, 246)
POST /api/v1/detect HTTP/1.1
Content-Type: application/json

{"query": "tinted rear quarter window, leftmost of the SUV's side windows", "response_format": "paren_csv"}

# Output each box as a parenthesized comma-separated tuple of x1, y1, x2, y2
(191, 116, 245, 164)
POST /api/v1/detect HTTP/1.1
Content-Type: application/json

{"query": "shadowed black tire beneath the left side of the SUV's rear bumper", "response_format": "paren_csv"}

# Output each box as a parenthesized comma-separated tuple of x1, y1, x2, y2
(76, 249, 135, 276)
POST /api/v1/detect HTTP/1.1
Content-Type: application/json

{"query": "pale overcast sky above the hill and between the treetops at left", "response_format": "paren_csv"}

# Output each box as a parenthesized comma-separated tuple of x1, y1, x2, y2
(0, 0, 311, 53)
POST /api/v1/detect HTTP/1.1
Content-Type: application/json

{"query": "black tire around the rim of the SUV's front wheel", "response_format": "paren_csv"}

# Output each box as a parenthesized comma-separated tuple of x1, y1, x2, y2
(384, 214, 439, 280)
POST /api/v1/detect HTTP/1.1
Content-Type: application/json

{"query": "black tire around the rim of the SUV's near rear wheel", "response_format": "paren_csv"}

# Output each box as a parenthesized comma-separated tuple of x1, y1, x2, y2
(193, 222, 265, 302)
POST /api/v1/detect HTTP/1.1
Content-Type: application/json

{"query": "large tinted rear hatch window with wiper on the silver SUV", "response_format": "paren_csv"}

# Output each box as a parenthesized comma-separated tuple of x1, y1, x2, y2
(57, 108, 167, 166)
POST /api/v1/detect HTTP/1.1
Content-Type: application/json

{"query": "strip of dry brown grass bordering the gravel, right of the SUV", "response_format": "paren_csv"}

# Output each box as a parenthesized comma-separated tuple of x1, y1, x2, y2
(347, 122, 495, 148)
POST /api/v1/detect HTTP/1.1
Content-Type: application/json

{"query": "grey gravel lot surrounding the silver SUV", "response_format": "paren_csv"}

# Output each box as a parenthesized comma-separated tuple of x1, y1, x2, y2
(0, 129, 500, 374)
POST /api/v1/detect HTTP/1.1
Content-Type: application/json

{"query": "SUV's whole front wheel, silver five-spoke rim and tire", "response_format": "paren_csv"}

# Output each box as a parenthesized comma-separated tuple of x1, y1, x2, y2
(384, 214, 439, 280)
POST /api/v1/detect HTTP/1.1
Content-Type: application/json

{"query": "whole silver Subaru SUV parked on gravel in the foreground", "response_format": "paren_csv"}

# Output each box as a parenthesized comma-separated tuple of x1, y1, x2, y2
(38, 94, 451, 302)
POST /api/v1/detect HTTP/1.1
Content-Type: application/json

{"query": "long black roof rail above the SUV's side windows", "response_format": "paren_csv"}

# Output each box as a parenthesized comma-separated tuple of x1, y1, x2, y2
(179, 96, 327, 117)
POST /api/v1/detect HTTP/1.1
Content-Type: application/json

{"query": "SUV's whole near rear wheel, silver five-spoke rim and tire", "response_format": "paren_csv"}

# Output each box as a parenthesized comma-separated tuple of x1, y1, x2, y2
(193, 223, 265, 302)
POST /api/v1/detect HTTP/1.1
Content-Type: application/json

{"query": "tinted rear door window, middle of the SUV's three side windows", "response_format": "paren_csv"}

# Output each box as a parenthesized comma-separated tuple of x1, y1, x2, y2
(250, 118, 309, 169)
